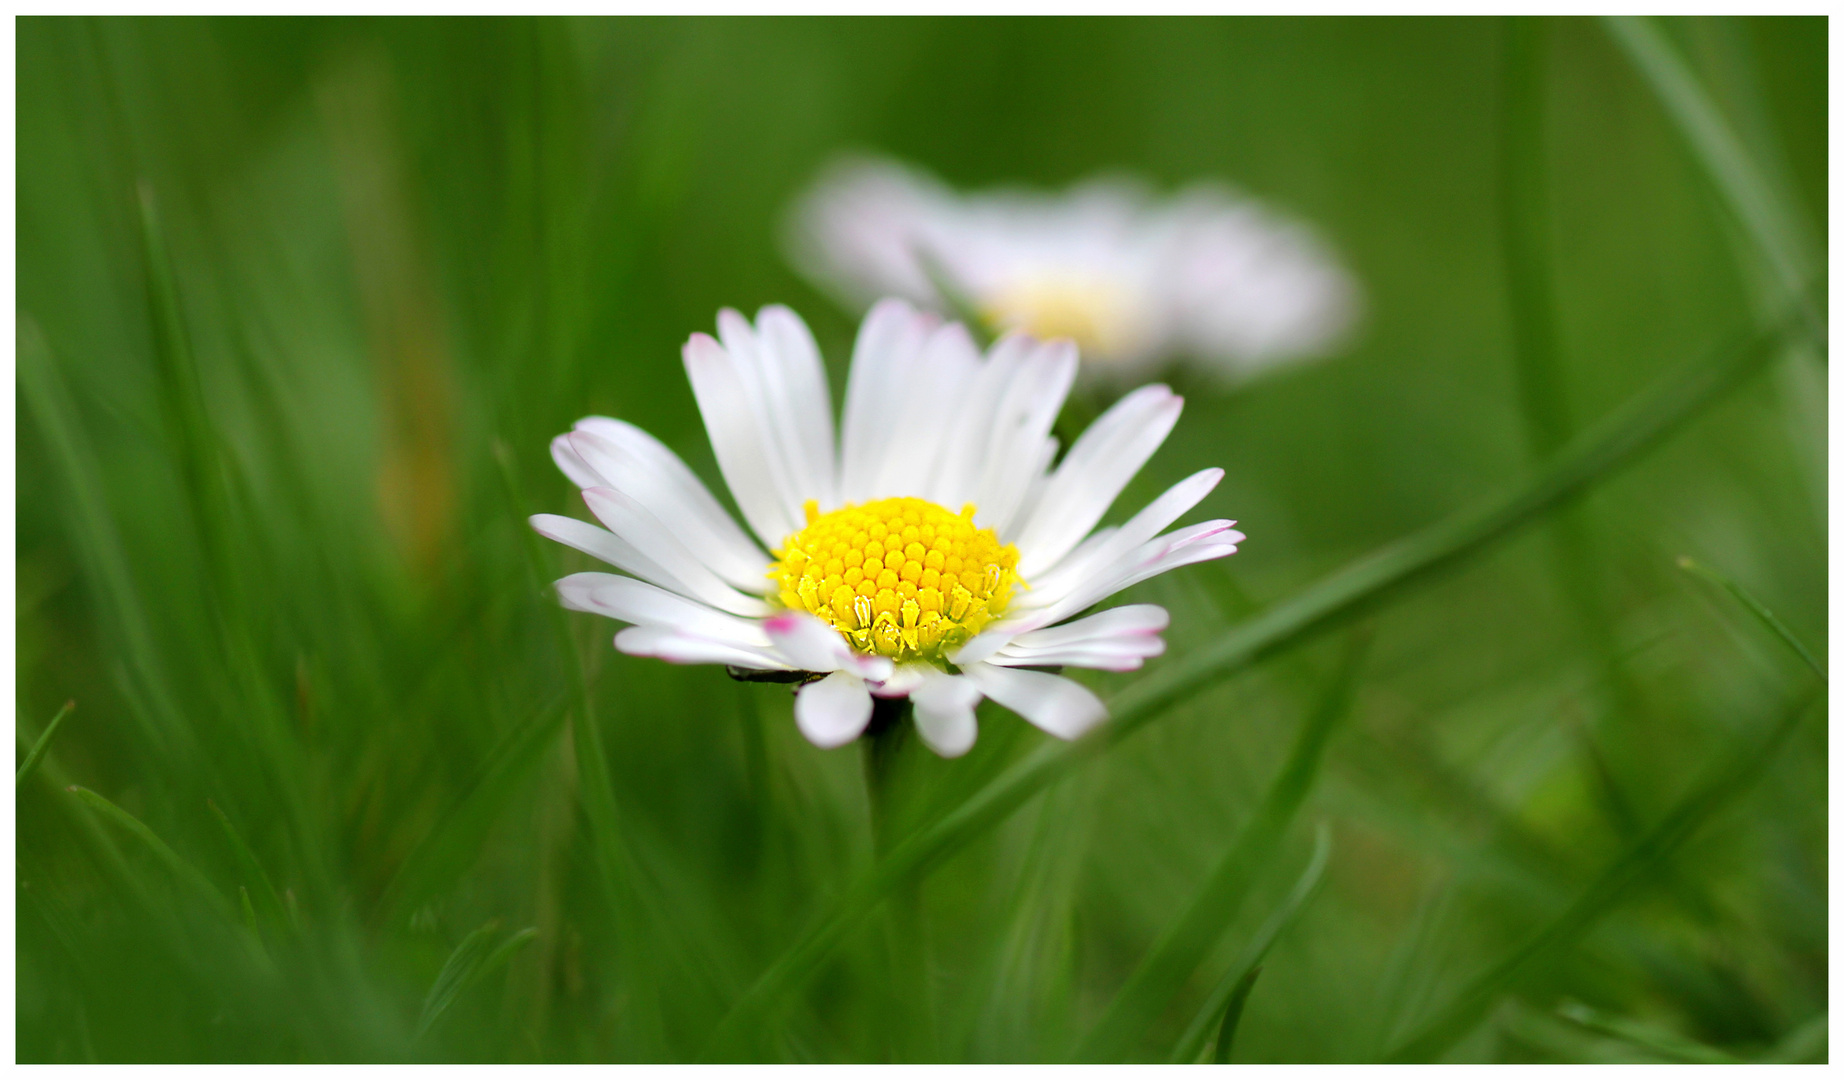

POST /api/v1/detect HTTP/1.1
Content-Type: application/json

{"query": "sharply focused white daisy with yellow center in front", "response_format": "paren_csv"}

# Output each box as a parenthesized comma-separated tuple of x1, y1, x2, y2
(531, 300, 1243, 757)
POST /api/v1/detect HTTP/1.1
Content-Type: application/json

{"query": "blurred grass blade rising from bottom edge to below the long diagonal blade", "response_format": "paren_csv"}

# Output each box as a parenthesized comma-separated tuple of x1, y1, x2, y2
(1075, 634, 1368, 1062)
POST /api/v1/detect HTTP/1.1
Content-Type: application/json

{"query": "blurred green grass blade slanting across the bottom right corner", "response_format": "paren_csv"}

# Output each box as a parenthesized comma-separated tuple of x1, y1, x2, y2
(1385, 685, 1814, 1063)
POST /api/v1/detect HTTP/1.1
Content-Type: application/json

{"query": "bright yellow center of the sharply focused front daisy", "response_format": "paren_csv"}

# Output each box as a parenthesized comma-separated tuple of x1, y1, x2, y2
(769, 498, 1023, 663)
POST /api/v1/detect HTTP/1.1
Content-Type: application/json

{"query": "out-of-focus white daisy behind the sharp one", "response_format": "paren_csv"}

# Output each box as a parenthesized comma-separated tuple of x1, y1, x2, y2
(787, 158, 1359, 382)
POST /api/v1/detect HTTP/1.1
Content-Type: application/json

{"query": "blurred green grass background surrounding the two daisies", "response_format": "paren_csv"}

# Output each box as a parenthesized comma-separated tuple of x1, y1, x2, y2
(15, 18, 1827, 1062)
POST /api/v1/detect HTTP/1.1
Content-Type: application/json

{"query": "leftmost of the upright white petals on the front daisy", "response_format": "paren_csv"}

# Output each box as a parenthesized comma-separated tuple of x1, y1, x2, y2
(684, 334, 798, 547)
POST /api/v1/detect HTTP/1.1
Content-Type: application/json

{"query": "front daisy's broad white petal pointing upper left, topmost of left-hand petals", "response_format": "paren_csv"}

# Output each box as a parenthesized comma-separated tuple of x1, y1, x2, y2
(568, 429, 769, 592)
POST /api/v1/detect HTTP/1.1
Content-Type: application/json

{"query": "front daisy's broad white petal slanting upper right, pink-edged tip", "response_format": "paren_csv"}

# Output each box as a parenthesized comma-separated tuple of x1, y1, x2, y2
(1016, 385, 1184, 581)
